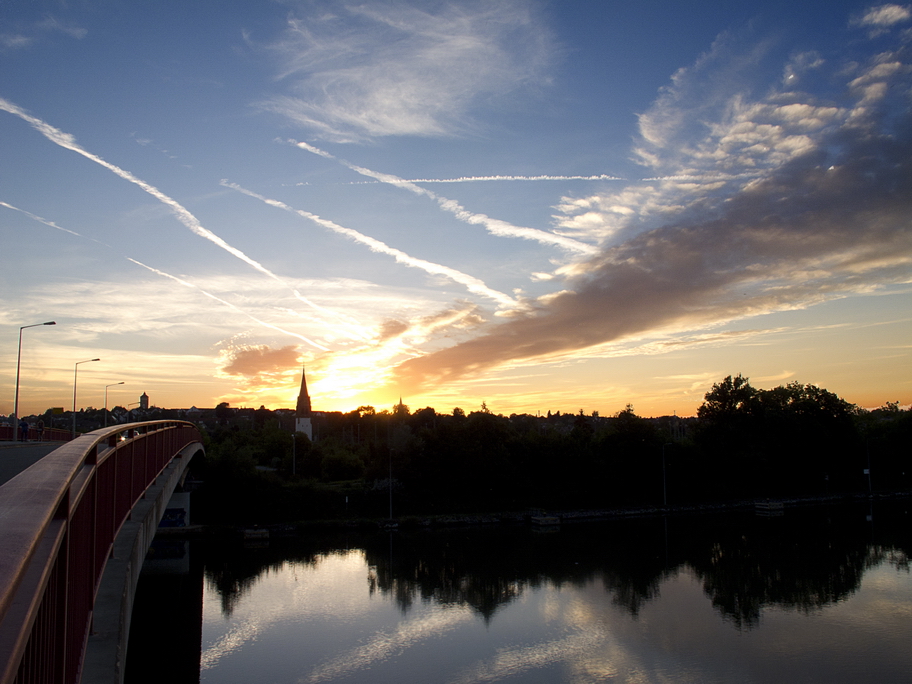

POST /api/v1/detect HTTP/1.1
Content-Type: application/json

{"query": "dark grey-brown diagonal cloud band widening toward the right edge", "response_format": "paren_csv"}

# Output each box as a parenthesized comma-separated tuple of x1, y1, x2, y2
(396, 107, 912, 392)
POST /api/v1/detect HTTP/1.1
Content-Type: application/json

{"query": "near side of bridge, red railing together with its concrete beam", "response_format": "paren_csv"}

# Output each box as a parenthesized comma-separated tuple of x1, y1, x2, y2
(0, 421, 203, 684)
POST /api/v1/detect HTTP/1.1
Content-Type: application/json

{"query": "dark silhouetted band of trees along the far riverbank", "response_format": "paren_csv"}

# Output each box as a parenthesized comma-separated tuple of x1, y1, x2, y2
(196, 375, 912, 522)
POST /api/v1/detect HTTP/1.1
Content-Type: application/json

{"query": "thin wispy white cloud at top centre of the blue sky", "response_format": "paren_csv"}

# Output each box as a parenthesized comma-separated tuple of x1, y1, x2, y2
(260, 0, 553, 142)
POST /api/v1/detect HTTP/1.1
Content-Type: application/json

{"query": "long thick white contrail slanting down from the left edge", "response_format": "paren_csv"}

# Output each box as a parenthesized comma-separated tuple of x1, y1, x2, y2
(0, 97, 338, 328)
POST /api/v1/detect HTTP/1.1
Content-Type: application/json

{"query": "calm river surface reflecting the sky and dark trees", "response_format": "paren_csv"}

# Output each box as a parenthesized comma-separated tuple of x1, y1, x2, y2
(128, 503, 912, 684)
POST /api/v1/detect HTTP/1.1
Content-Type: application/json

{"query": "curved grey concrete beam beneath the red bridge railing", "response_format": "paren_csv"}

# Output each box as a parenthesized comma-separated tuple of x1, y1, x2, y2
(81, 443, 203, 684)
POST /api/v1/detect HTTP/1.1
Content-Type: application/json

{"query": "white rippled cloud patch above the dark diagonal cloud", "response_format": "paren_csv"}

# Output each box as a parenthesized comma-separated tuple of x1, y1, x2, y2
(556, 13, 909, 248)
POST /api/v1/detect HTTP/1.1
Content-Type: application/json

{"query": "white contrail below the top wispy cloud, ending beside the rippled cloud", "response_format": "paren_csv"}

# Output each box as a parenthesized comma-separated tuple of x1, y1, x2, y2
(289, 140, 598, 255)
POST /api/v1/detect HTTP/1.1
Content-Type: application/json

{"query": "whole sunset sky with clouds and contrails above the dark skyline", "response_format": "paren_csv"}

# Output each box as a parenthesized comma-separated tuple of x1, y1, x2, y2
(0, 0, 912, 416)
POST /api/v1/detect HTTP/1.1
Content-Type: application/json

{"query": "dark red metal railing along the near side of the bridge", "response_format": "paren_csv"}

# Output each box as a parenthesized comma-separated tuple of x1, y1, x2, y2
(0, 421, 201, 684)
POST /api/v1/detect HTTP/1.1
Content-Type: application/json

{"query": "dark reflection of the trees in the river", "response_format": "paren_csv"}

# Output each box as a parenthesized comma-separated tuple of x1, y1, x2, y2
(205, 501, 912, 630)
